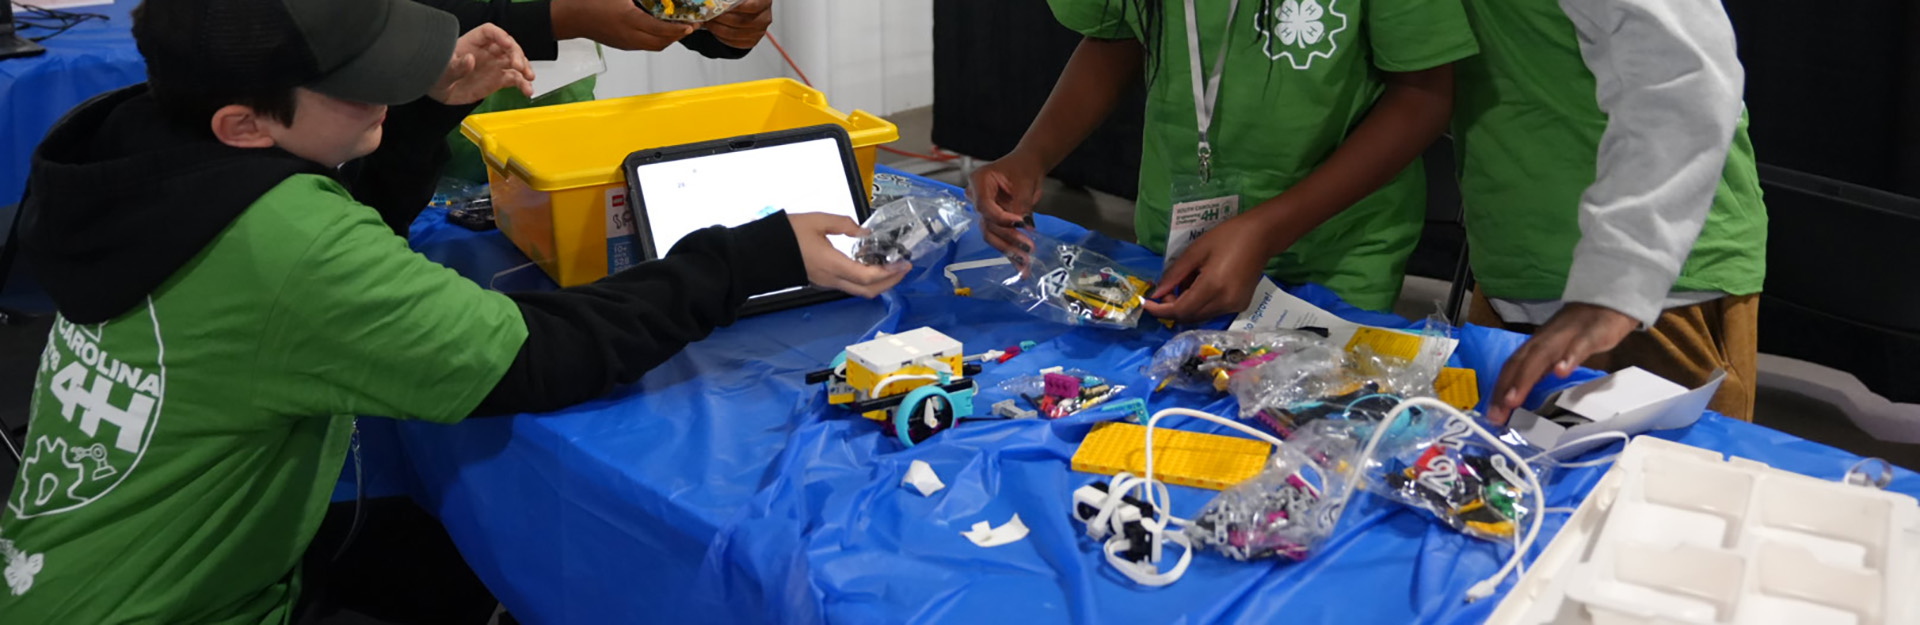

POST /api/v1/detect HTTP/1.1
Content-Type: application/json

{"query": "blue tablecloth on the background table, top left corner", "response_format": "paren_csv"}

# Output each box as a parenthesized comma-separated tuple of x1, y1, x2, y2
(0, 0, 146, 205)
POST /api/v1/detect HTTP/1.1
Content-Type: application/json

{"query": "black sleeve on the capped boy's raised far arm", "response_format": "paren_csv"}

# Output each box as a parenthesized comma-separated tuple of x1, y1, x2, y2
(340, 98, 478, 236)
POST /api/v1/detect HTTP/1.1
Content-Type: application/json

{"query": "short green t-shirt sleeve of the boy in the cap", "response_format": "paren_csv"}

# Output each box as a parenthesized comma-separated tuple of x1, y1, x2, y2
(255, 183, 526, 422)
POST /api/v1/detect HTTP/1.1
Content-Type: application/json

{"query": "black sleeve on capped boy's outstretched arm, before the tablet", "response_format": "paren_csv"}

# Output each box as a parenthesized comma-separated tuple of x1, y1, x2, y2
(474, 213, 806, 416)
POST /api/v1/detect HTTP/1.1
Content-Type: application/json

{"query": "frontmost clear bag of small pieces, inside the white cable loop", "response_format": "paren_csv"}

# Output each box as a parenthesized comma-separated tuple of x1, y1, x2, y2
(1187, 422, 1363, 562)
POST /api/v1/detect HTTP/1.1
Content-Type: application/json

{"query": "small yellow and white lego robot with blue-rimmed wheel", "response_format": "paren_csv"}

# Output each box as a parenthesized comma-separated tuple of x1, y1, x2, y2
(806, 328, 979, 447)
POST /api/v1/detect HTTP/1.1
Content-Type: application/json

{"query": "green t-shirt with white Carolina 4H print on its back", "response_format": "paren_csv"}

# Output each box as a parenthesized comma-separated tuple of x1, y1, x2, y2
(0, 174, 526, 623)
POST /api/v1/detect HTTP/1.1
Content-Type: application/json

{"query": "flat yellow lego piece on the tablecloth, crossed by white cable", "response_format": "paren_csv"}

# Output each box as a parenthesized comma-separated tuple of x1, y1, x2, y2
(1073, 422, 1273, 491)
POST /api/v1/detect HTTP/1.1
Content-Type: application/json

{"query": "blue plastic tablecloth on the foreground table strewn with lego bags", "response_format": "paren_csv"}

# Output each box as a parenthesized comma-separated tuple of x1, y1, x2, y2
(397, 166, 1920, 625)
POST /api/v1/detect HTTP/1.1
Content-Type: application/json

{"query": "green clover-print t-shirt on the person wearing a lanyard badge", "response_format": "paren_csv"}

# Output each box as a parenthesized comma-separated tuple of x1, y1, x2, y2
(1048, 0, 1476, 309)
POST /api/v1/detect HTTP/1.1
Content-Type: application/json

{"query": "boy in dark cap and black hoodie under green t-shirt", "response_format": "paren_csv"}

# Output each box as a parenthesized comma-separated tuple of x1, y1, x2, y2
(0, 0, 900, 623)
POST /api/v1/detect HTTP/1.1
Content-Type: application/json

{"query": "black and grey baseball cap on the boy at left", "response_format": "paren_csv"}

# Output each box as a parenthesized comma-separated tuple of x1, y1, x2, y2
(132, 0, 459, 104)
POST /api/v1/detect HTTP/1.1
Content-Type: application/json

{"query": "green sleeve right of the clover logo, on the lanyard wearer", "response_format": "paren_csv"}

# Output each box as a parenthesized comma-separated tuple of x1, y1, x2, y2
(1367, 0, 1480, 71)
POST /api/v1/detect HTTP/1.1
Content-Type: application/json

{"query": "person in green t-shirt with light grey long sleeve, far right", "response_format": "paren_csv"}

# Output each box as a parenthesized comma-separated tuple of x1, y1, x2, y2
(1453, 0, 1766, 422)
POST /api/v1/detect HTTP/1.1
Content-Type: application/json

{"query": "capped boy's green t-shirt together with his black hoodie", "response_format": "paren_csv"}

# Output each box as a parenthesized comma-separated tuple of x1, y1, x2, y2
(0, 74, 804, 623)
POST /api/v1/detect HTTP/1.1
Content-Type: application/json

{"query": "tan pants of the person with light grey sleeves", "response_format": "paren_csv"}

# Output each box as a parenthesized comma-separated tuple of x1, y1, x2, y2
(1467, 288, 1761, 422)
